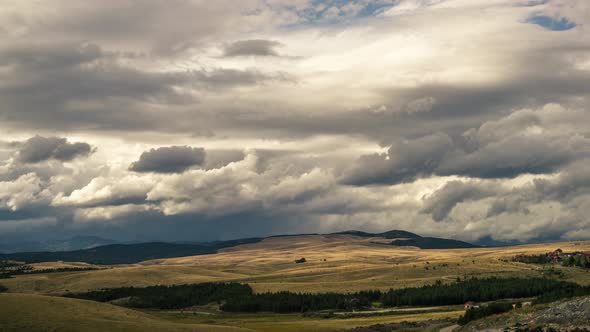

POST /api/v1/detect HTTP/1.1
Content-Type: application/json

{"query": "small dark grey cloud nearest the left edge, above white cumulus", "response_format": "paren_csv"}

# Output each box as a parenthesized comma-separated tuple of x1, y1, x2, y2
(18, 136, 93, 163)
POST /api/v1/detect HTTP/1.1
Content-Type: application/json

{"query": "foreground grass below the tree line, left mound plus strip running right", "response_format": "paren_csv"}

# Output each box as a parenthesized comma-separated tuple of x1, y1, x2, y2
(0, 294, 462, 332)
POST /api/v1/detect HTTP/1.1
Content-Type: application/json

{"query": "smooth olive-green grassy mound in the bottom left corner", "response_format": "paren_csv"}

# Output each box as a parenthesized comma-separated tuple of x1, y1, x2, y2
(0, 294, 248, 332)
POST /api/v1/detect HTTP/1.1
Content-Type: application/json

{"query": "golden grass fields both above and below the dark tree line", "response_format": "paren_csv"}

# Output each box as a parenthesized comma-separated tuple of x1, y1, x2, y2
(0, 235, 590, 332)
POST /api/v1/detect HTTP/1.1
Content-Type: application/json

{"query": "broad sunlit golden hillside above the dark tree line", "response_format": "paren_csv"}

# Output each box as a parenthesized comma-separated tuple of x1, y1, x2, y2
(0, 235, 590, 294)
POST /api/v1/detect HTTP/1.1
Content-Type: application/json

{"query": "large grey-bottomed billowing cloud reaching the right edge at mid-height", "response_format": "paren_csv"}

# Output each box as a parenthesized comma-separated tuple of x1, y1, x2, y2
(342, 105, 590, 185)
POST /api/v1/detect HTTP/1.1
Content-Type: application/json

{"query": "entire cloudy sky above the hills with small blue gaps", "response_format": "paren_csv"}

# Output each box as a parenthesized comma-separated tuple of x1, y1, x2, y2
(0, 0, 590, 243)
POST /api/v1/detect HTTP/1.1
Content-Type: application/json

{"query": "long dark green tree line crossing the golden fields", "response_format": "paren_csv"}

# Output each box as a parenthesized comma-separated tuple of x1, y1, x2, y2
(65, 278, 590, 313)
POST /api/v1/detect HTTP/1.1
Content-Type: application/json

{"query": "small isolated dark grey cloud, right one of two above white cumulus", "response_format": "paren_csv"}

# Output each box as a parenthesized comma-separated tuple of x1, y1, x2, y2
(129, 146, 205, 173)
